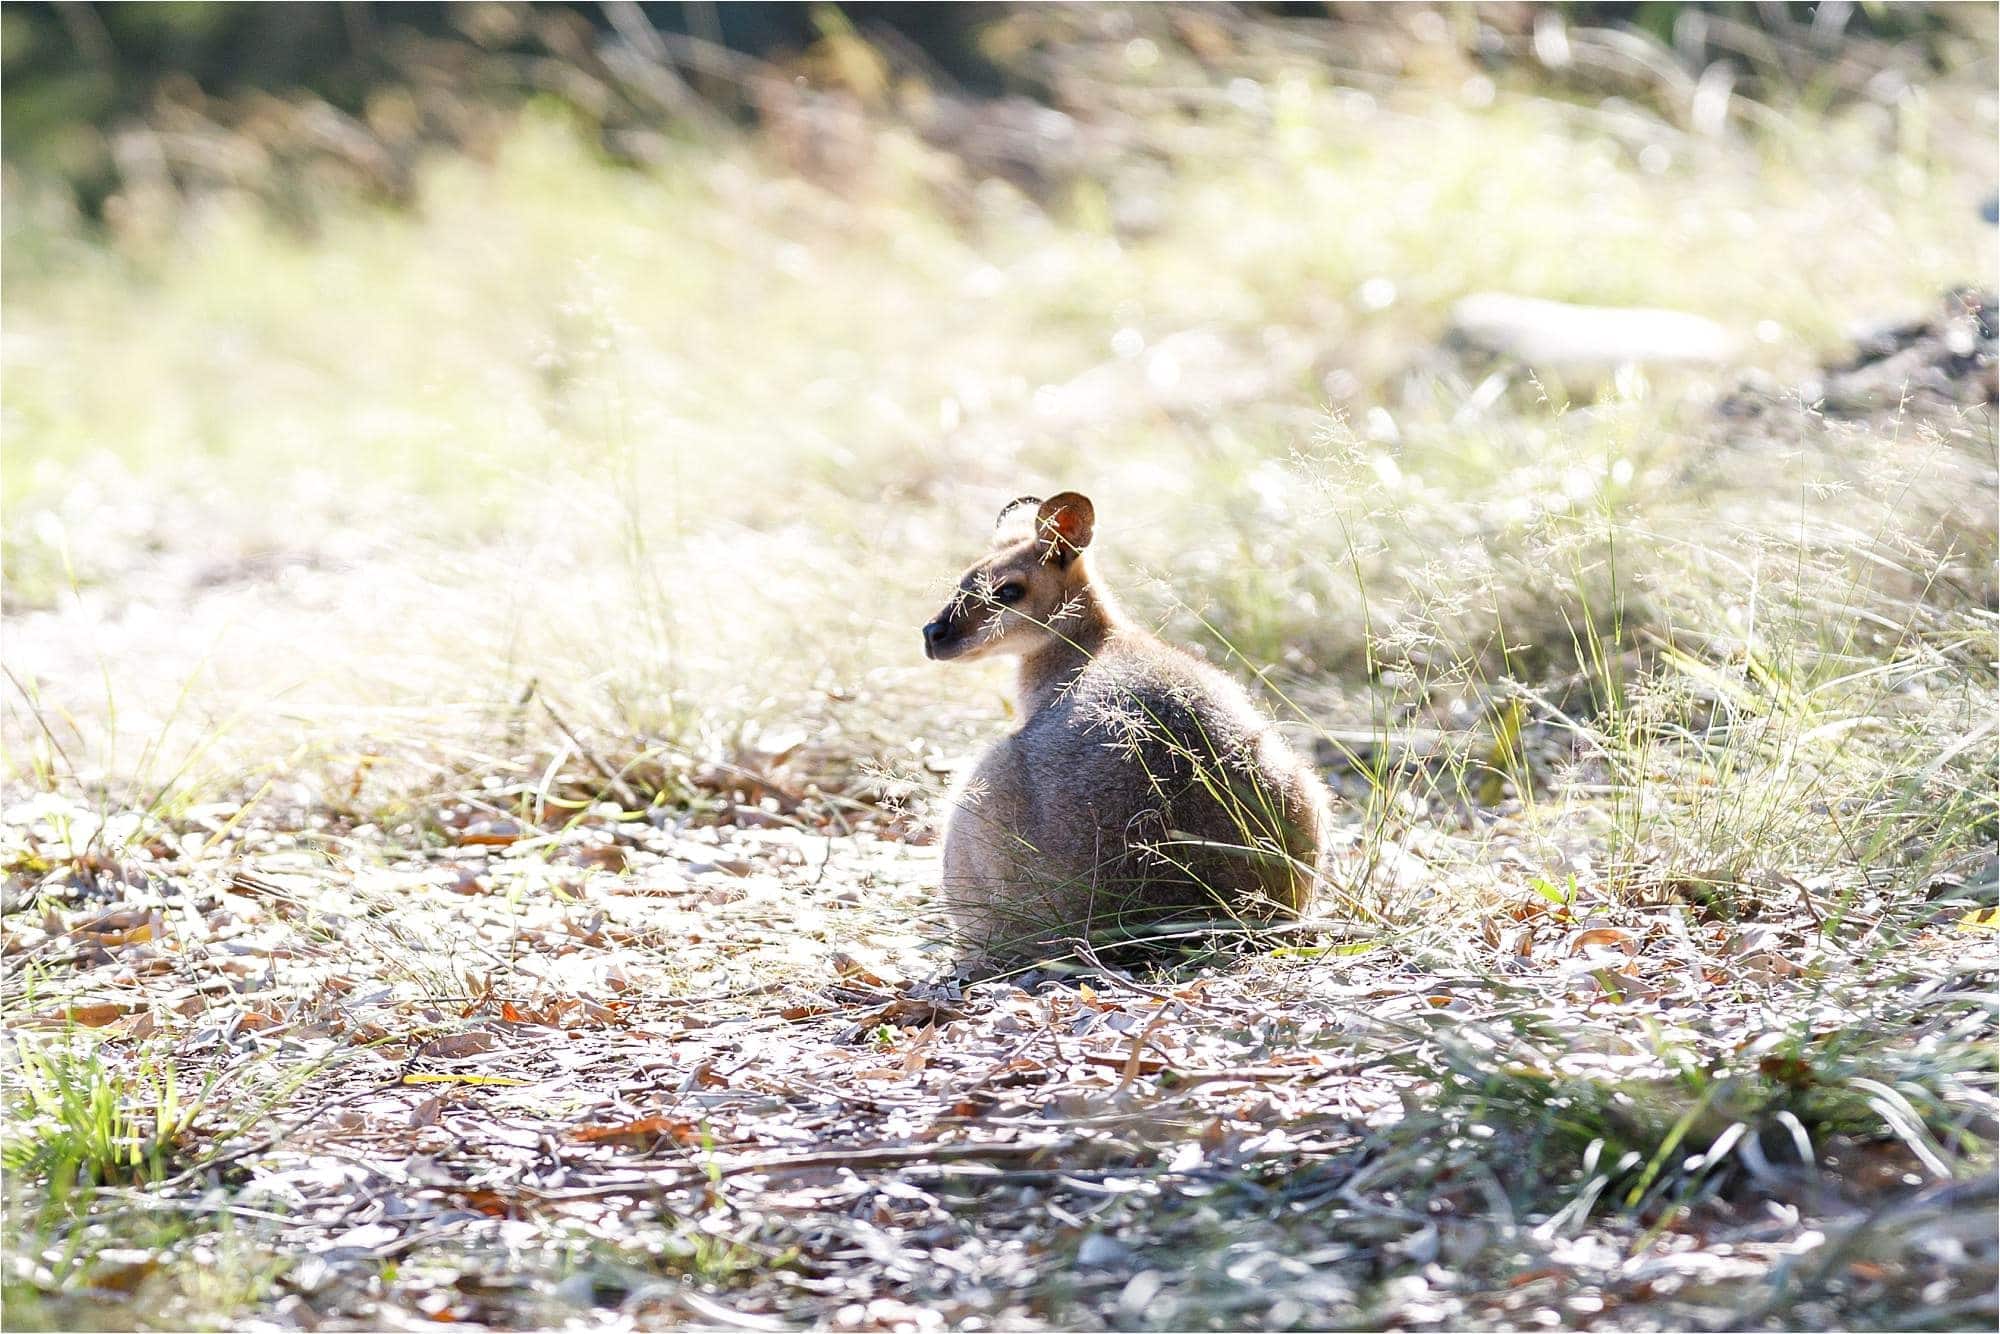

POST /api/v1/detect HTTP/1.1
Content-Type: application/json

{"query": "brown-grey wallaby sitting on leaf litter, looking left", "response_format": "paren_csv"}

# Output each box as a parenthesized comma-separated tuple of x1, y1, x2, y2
(924, 492, 1328, 956)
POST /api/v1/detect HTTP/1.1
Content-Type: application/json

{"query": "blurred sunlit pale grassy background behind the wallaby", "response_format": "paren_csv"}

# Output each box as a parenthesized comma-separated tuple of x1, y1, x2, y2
(4, 6, 1994, 888)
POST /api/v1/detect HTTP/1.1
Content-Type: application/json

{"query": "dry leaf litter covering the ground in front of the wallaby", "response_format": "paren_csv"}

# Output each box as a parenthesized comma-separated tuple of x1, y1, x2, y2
(6, 776, 1996, 1330)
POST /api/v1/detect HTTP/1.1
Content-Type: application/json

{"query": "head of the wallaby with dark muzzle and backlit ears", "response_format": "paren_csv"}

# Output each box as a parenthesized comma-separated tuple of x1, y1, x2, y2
(924, 492, 1096, 662)
